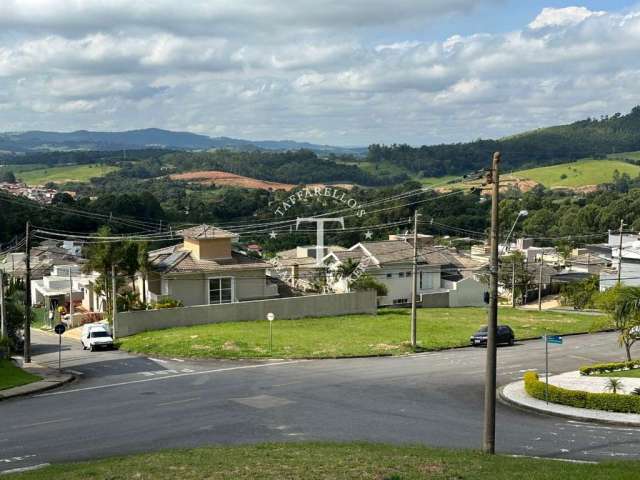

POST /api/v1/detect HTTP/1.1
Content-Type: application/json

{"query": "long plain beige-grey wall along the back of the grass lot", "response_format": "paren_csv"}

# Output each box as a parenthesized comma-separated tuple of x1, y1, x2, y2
(115, 290, 377, 337)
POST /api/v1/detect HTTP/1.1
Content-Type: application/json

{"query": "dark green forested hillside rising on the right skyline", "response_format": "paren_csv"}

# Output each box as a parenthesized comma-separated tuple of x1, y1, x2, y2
(367, 106, 640, 177)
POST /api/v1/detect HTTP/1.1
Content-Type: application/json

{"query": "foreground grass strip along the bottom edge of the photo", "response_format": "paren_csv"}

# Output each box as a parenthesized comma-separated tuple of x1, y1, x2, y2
(7, 443, 640, 480)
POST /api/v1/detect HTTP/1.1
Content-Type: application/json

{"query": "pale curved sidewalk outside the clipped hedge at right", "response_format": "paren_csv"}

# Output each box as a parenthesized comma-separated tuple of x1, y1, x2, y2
(498, 372, 640, 427)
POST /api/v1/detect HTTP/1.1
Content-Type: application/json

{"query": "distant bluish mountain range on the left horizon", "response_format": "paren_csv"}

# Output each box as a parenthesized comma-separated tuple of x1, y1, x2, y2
(0, 128, 367, 155)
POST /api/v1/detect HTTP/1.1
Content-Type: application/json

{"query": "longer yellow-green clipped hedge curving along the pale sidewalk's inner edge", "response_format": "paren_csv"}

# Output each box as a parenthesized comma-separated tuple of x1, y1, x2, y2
(524, 372, 640, 413)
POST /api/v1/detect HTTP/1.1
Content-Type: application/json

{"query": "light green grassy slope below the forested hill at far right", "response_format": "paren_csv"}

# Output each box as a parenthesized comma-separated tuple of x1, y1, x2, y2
(513, 159, 640, 188)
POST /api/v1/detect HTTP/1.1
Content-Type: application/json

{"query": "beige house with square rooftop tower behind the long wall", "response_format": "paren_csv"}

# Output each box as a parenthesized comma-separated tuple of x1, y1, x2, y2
(145, 225, 278, 306)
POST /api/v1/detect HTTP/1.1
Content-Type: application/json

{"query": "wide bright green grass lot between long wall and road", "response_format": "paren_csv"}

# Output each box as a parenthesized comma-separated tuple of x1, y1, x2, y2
(120, 308, 600, 358)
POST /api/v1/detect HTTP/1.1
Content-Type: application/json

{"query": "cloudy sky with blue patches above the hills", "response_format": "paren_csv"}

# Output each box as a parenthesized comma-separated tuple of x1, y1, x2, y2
(0, 0, 640, 146)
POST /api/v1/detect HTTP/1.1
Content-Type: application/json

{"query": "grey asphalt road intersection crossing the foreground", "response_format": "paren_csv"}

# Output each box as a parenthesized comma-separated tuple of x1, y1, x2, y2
(0, 333, 640, 470)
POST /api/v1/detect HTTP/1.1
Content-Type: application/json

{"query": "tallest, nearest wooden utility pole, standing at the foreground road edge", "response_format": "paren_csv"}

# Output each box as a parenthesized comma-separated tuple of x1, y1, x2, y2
(482, 152, 500, 454)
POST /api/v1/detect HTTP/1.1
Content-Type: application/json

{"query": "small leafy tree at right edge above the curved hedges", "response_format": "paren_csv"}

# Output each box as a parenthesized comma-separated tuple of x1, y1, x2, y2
(599, 285, 640, 362)
